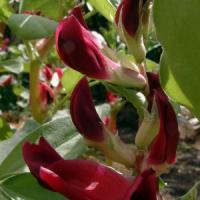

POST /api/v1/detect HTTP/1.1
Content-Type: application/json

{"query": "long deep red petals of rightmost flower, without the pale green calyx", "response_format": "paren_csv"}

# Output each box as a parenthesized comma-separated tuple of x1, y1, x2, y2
(147, 73, 179, 165)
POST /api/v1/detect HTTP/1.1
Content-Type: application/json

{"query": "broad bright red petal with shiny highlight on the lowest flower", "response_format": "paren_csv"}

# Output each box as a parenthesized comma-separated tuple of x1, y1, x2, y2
(40, 160, 131, 200)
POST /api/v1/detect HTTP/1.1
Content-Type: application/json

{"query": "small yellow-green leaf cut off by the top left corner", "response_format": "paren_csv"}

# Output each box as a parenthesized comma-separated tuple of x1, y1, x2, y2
(0, 0, 13, 23)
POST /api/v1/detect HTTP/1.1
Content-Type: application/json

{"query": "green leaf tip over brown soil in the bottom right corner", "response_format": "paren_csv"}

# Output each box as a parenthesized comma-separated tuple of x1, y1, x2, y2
(176, 182, 200, 200)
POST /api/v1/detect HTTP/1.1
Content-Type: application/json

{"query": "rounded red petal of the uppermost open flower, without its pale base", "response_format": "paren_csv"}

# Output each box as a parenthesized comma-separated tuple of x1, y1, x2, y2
(56, 15, 108, 79)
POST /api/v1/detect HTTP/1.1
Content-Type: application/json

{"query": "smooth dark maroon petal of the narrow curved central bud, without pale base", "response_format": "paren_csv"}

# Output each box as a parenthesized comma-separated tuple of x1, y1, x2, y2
(70, 77, 104, 142)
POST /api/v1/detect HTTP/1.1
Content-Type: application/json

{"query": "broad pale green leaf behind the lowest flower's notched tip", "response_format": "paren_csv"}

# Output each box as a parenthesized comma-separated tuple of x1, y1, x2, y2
(0, 117, 85, 177)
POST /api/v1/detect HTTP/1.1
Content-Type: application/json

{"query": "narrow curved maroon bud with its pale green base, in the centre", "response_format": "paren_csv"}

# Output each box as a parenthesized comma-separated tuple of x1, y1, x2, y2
(70, 77, 136, 166)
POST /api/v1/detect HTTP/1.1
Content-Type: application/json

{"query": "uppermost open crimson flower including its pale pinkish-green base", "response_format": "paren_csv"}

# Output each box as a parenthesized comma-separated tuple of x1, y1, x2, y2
(56, 8, 146, 88)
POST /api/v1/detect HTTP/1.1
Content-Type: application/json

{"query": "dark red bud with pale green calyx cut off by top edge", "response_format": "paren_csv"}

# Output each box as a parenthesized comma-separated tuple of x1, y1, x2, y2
(115, 0, 149, 63)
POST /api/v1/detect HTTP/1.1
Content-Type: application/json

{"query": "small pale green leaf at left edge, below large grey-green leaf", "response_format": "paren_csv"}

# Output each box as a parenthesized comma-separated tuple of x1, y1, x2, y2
(0, 59, 23, 74)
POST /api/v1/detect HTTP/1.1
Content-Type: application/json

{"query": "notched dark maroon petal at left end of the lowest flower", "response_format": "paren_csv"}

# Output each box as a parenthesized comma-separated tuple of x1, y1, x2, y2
(22, 137, 62, 178)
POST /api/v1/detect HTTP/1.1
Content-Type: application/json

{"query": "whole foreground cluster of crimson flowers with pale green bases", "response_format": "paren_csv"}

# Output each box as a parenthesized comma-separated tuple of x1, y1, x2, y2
(23, 3, 179, 200)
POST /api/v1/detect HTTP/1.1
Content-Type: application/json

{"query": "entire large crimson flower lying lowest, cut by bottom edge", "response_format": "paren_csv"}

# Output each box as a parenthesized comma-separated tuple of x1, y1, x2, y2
(23, 137, 157, 200)
